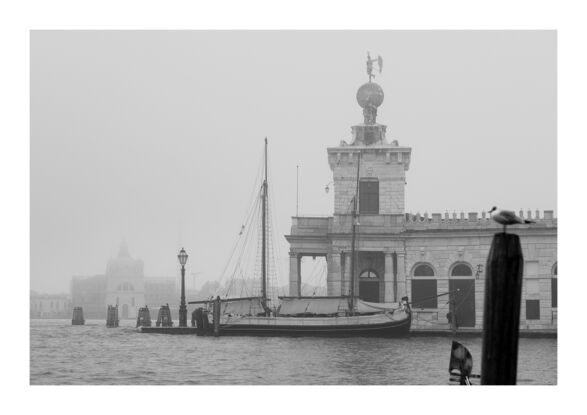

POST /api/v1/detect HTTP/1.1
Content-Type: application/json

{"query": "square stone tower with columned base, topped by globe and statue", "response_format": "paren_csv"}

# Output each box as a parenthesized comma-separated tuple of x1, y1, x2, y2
(286, 54, 412, 302)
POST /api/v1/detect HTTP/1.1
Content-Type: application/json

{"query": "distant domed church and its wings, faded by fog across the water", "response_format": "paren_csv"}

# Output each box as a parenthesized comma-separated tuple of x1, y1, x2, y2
(71, 243, 179, 319)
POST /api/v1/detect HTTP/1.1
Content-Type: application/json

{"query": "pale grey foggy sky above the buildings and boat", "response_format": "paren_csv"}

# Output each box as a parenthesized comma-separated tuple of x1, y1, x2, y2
(31, 31, 557, 292)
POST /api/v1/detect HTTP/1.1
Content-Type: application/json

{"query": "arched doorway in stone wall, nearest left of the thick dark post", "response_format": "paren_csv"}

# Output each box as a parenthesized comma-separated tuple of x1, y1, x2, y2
(448, 263, 475, 327)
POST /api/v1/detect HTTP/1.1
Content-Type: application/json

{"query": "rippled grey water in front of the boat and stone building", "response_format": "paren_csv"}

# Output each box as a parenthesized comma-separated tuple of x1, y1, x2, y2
(31, 320, 557, 385)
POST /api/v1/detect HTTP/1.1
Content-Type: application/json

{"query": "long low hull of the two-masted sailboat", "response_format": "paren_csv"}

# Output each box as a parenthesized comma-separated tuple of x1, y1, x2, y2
(219, 314, 411, 337)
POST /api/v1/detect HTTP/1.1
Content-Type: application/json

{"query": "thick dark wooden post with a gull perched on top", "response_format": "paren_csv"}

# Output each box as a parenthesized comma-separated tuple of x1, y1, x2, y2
(481, 233, 524, 385)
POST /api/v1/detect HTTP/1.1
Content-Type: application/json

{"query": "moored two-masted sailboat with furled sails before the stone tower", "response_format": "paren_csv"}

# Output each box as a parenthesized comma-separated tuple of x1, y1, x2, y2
(189, 138, 411, 337)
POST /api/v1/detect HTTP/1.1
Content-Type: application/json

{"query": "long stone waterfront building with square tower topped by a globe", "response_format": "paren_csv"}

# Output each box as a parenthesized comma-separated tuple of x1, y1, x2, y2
(286, 65, 557, 330)
